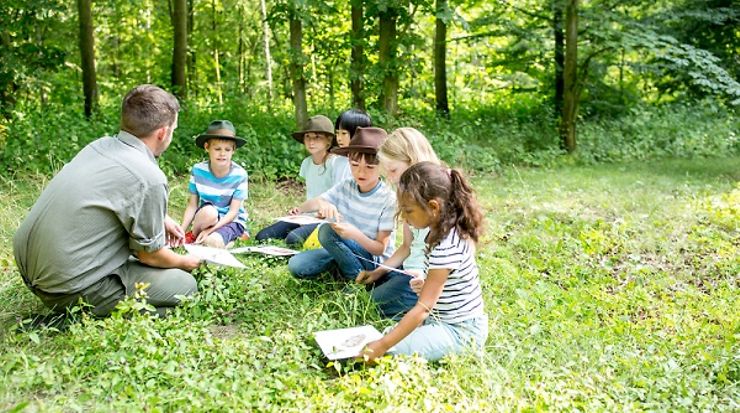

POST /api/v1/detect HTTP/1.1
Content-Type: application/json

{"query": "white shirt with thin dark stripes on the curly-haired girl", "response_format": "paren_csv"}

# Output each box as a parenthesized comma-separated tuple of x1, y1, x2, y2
(426, 228, 483, 324)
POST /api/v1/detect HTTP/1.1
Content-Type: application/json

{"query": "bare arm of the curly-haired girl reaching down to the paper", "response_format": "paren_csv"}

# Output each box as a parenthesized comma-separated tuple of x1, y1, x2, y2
(360, 268, 450, 361)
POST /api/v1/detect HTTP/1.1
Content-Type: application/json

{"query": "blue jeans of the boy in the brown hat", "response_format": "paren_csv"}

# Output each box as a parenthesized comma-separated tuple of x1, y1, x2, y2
(288, 224, 375, 280)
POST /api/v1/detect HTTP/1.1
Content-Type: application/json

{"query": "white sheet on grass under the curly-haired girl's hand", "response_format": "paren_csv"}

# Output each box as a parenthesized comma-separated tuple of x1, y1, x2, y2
(314, 325, 383, 360)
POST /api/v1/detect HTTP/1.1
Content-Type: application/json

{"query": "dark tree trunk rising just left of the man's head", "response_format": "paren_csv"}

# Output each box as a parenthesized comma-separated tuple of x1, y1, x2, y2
(77, 0, 98, 118)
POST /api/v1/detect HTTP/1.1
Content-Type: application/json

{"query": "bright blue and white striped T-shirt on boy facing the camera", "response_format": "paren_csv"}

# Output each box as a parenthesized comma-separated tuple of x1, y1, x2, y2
(188, 161, 248, 226)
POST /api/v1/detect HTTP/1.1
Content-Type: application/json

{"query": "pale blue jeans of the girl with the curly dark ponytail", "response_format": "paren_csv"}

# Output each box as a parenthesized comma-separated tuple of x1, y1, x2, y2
(388, 314, 488, 361)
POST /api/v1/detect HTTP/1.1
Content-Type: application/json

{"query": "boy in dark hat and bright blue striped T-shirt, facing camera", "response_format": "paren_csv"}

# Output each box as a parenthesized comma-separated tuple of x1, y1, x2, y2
(182, 120, 248, 248)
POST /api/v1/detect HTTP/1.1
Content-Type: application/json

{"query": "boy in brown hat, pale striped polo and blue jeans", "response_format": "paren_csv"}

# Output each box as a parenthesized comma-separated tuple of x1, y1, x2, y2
(288, 127, 396, 280)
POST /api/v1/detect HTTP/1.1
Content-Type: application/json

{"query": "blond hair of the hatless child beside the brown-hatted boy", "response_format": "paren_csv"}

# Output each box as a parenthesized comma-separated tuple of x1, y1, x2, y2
(378, 128, 440, 165)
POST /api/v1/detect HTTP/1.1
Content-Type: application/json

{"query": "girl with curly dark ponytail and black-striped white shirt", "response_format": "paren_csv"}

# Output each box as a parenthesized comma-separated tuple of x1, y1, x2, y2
(361, 162, 488, 361)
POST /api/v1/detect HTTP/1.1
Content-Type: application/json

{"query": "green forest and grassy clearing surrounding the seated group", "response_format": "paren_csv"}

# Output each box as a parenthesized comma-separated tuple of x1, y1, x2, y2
(0, 0, 740, 411)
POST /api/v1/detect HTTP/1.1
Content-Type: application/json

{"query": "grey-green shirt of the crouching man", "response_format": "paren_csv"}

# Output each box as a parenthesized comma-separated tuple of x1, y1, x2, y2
(13, 131, 168, 294)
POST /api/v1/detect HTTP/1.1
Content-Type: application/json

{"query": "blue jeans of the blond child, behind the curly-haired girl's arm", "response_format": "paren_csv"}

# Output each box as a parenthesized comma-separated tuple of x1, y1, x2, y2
(370, 271, 419, 318)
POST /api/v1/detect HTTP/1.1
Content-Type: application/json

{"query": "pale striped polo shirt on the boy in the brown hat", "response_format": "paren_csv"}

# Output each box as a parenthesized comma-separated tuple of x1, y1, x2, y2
(319, 178, 396, 261)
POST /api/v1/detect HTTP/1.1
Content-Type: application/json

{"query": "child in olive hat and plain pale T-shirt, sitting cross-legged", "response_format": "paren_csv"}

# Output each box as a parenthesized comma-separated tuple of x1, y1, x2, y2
(255, 115, 351, 245)
